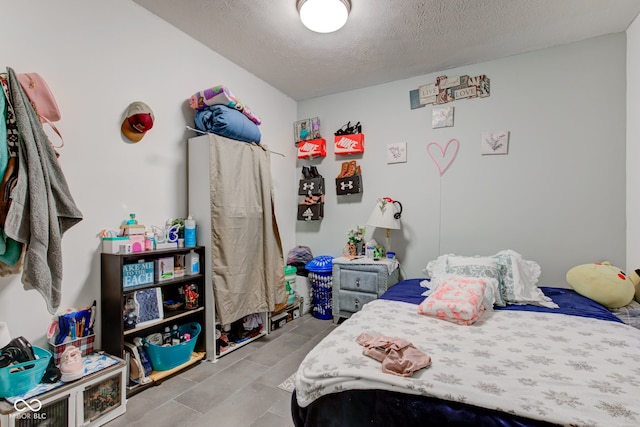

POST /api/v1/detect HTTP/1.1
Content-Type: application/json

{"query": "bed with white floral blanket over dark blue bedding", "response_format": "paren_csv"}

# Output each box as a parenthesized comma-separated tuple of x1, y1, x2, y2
(291, 270, 640, 427)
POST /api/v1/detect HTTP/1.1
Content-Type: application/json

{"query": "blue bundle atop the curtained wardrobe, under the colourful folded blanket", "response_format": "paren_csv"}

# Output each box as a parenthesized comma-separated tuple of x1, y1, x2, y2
(194, 105, 261, 144)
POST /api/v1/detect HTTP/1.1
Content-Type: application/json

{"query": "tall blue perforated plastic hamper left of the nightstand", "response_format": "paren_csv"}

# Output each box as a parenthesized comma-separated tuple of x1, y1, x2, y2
(305, 255, 333, 320)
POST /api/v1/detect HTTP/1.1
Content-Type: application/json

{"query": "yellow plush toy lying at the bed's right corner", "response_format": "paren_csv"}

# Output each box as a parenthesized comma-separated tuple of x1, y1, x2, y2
(567, 261, 636, 308)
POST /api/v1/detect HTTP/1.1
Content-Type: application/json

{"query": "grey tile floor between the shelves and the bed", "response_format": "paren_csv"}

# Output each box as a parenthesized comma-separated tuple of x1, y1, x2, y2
(106, 314, 335, 427)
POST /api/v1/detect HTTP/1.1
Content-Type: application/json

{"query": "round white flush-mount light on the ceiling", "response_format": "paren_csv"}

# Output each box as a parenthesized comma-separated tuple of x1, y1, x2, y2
(297, 0, 351, 33)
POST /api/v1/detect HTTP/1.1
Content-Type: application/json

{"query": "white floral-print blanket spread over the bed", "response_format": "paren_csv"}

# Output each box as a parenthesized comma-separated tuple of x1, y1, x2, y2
(296, 300, 640, 427)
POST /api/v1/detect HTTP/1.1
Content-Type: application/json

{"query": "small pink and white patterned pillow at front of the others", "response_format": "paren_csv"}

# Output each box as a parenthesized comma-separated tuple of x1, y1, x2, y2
(418, 277, 487, 325)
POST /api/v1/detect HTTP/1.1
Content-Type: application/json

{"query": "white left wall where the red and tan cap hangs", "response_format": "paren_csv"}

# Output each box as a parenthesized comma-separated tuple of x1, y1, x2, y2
(0, 0, 296, 345)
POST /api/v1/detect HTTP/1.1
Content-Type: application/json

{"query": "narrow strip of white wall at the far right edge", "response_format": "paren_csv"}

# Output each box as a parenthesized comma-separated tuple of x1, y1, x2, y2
(625, 17, 640, 271)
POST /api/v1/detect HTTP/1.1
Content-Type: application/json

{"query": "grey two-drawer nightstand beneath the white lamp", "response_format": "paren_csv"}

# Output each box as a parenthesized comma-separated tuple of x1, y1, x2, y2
(332, 257, 399, 322)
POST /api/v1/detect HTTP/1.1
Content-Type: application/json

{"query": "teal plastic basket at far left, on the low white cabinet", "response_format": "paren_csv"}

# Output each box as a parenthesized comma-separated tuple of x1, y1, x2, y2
(0, 346, 52, 398)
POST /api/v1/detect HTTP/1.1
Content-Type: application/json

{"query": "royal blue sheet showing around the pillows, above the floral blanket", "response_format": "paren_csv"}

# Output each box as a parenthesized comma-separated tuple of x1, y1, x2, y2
(380, 279, 623, 323)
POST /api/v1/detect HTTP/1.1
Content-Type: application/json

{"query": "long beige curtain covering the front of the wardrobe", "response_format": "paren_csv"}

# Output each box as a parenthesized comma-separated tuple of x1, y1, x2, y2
(209, 134, 286, 324)
